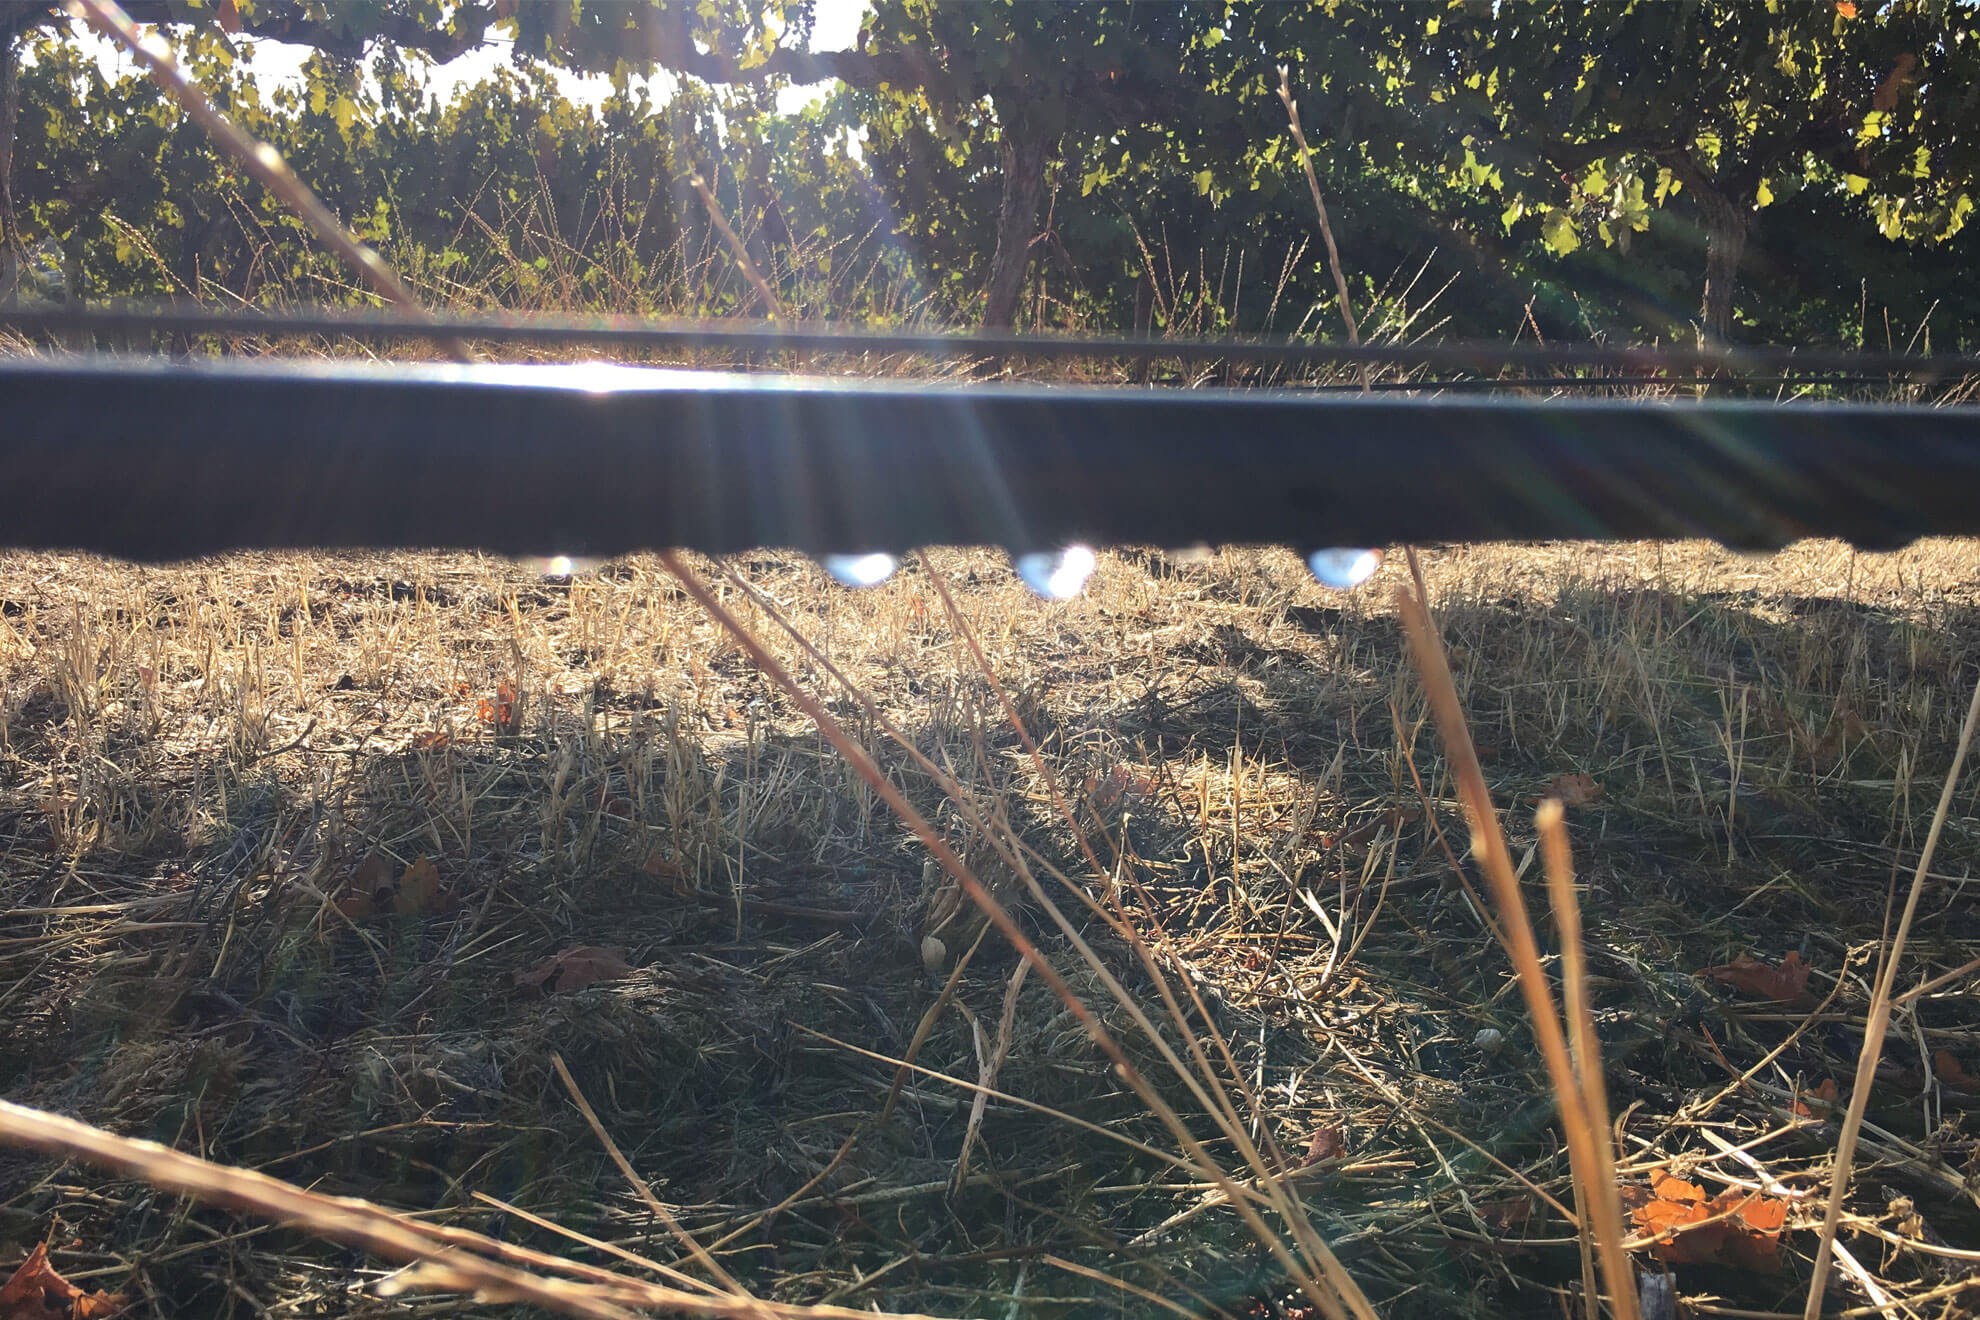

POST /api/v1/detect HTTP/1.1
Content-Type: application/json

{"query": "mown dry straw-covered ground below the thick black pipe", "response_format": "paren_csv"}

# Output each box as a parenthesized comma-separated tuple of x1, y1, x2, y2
(0, 542, 1980, 1316)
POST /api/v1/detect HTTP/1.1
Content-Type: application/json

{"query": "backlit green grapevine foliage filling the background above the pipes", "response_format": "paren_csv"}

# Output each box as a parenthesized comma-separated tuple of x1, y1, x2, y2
(14, 0, 1980, 346)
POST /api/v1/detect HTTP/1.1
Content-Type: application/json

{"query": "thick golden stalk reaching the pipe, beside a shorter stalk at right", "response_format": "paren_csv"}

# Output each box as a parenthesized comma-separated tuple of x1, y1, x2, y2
(1396, 588, 1637, 1320)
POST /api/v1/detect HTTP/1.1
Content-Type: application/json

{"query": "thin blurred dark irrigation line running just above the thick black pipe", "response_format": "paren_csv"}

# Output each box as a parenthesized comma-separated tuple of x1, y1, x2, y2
(11, 305, 1980, 384)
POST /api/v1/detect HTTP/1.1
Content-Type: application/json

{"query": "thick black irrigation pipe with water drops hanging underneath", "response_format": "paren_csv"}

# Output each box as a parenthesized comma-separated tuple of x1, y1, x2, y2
(0, 358, 1980, 560)
